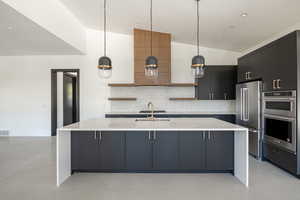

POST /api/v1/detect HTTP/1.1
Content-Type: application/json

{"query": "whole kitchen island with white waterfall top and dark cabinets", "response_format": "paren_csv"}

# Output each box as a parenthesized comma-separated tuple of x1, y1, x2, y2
(57, 118, 248, 187)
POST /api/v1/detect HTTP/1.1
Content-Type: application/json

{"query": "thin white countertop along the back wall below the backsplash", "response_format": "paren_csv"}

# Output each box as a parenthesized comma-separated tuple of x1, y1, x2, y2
(106, 111, 236, 115)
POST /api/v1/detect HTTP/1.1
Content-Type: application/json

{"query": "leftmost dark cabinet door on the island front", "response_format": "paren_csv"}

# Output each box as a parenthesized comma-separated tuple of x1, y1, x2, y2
(71, 131, 100, 171)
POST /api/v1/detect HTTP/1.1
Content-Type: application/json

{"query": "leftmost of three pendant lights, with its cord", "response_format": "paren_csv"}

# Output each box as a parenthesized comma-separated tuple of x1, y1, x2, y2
(98, 0, 112, 78)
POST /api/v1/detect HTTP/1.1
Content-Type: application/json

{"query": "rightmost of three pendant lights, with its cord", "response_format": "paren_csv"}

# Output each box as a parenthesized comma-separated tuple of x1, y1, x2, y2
(191, 0, 205, 78)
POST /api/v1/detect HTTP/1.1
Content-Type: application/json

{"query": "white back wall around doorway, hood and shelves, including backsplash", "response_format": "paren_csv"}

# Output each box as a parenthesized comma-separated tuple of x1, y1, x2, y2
(0, 30, 239, 136)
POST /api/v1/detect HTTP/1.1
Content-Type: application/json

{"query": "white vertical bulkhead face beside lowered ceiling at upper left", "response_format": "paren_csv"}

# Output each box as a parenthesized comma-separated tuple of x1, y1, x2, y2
(2, 0, 86, 53)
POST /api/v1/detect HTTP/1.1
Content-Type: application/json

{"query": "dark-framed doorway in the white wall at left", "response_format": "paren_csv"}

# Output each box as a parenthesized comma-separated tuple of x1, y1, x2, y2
(51, 69, 80, 136)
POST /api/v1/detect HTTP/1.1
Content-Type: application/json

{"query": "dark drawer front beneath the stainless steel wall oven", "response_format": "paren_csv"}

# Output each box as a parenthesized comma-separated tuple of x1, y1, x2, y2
(263, 143, 297, 174)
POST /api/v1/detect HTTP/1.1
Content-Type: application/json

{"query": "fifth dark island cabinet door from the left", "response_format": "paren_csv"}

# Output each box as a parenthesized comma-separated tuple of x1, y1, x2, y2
(179, 131, 205, 170)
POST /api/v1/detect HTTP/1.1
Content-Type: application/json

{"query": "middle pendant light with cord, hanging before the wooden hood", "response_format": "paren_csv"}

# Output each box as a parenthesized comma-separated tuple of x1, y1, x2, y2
(145, 0, 158, 78)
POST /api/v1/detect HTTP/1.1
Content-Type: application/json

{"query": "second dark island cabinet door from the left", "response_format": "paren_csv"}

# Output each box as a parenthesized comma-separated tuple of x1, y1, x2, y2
(99, 132, 125, 171)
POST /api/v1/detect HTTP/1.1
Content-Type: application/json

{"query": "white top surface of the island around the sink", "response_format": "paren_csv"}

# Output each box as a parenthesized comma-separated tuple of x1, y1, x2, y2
(58, 118, 248, 131)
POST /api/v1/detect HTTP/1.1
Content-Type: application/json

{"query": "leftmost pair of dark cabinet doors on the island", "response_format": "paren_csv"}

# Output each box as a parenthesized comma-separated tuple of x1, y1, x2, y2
(71, 132, 125, 171)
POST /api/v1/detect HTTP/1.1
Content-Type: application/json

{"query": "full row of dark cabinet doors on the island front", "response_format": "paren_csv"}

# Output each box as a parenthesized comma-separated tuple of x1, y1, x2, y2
(71, 131, 234, 172)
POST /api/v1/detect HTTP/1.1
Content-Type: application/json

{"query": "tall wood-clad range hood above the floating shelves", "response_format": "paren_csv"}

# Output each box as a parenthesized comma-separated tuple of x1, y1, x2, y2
(134, 29, 171, 85)
